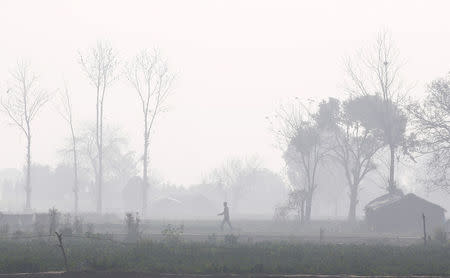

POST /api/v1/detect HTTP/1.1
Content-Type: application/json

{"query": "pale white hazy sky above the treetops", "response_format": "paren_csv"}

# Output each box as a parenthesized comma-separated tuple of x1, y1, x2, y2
(0, 0, 450, 185)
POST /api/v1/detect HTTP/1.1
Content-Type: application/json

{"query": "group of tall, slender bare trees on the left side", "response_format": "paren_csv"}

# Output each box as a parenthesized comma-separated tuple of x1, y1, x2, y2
(1, 42, 174, 216)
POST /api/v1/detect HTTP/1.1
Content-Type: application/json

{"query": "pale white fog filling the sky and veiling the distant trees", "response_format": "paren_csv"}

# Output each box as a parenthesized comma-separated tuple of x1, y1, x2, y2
(0, 0, 450, 224)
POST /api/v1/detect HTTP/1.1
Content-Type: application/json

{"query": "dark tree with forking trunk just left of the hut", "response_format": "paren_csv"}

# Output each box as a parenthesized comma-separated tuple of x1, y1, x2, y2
(318, 98, 383, 221)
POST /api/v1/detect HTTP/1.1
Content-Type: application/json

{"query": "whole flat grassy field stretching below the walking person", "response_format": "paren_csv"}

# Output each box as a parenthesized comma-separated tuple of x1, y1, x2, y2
(0, 220, 450, 277)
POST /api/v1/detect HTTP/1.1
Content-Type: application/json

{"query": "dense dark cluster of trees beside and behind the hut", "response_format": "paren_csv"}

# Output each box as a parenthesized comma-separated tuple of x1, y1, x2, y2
(276, 32, 450, 221)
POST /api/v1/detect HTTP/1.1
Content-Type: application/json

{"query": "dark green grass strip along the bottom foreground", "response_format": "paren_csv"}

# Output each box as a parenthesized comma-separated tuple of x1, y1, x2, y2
(0, 239, 450, 275)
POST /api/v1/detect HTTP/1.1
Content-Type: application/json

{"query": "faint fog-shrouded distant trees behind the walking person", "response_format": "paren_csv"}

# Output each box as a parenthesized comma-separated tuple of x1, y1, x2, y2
(116, 158, 287, 219)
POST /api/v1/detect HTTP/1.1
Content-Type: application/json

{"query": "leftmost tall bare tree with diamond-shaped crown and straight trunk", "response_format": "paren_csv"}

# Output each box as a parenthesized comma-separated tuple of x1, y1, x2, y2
(1, 62, 49, 210)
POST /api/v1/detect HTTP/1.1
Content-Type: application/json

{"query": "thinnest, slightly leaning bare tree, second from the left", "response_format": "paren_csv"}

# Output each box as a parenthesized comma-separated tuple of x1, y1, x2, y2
(60, 84, 79, 215)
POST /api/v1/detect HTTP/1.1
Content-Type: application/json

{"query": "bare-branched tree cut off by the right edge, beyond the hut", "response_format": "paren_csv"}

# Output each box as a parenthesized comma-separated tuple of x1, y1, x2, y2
(408, 74, 450, 190)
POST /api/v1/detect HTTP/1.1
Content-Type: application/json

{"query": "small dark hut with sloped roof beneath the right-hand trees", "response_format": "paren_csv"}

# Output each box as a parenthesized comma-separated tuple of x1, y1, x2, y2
(365, 193, 446, 235)
